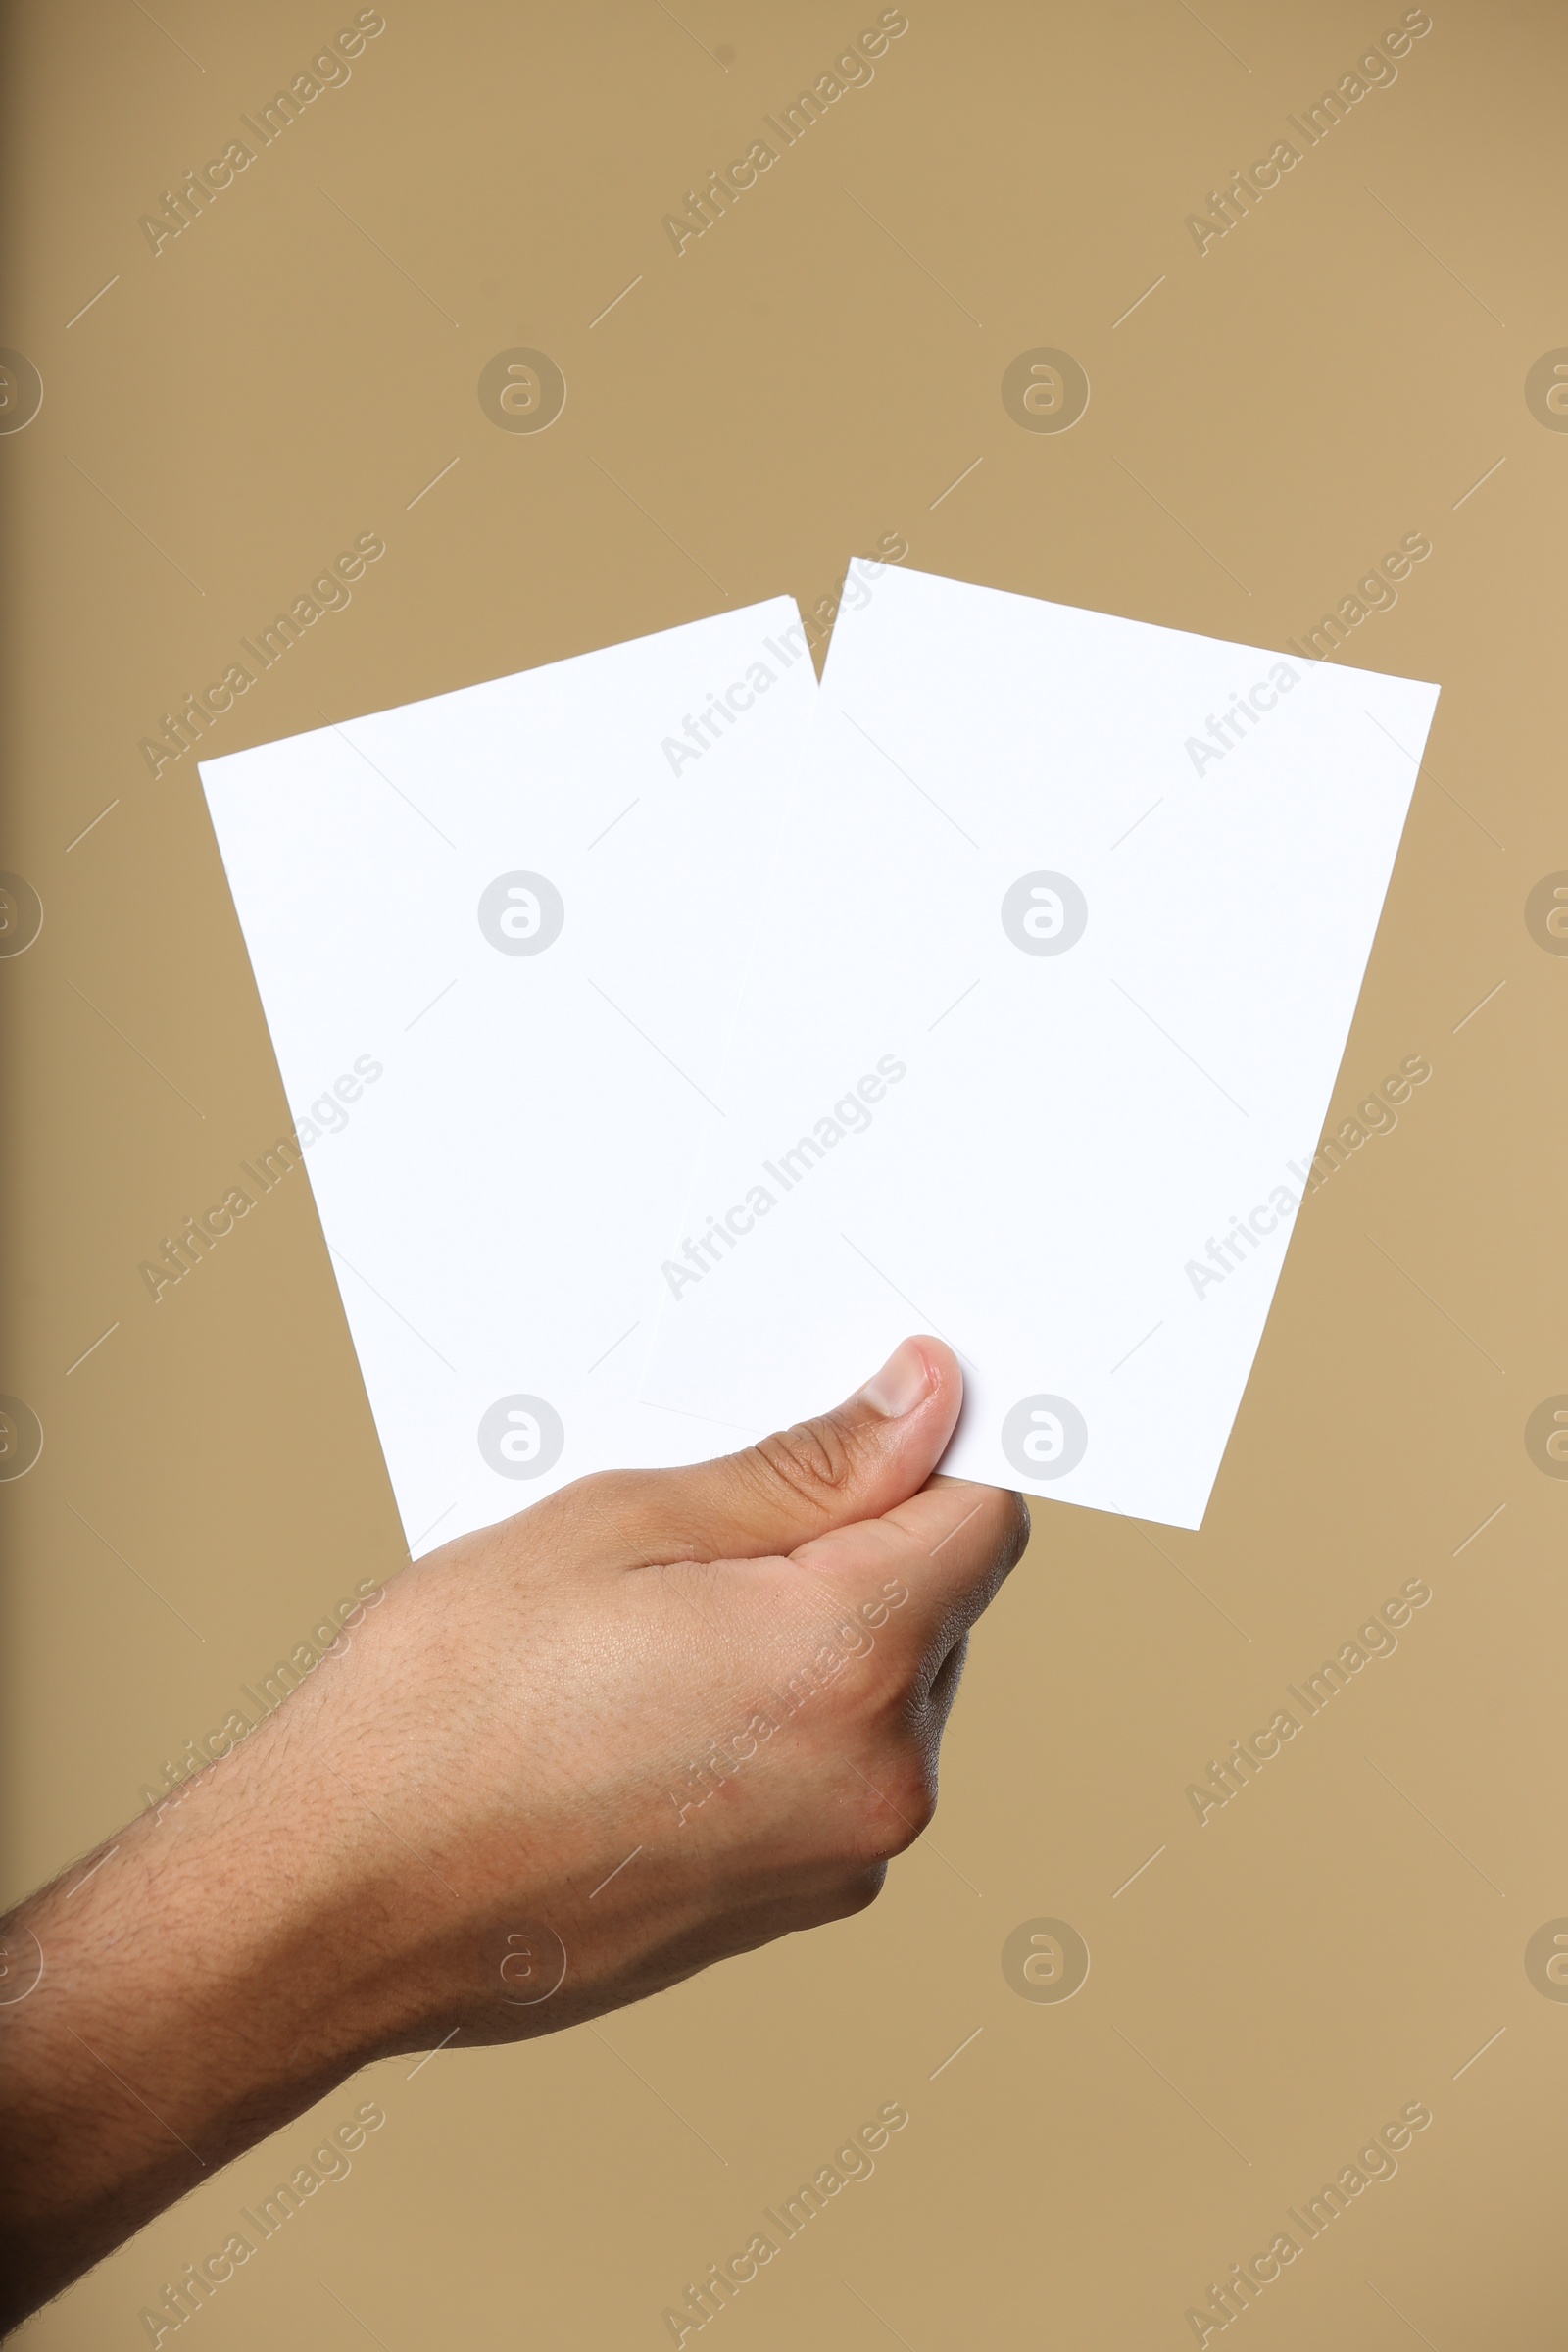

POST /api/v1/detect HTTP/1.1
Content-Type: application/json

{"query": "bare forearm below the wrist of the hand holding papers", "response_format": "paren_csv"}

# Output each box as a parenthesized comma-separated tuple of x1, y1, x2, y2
(0, 1710, 411, 2327)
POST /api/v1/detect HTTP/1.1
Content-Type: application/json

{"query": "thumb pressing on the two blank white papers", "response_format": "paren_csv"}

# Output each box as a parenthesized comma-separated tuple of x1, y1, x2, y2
(595, 1339, 964, 1566)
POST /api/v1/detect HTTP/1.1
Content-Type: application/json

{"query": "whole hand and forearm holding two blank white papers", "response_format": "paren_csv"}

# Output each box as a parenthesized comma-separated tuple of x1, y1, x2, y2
(0, 1339, 1030, 2327)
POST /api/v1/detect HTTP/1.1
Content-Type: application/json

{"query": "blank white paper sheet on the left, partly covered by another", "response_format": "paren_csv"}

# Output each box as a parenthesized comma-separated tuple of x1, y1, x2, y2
(202, 598, 815, 1552)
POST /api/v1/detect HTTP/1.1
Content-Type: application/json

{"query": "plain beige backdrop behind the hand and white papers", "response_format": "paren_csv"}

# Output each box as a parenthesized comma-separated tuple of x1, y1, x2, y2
(0, 0, 1568, 2352)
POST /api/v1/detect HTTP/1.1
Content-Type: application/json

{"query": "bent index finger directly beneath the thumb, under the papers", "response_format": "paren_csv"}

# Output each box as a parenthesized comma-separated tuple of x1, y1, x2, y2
(792, 1480, 1030, 1672)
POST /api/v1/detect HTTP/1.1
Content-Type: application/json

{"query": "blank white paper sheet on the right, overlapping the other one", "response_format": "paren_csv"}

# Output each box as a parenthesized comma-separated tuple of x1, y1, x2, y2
(644, 564, 1437, 1527)
